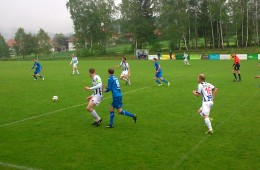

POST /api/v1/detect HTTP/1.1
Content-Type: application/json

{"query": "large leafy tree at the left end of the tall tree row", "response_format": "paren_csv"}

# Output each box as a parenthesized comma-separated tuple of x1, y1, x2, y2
(66, 0, 115, 52)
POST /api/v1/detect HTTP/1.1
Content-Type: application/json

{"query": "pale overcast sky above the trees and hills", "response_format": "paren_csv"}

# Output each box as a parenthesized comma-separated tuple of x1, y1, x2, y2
(0, 0, 121, 39)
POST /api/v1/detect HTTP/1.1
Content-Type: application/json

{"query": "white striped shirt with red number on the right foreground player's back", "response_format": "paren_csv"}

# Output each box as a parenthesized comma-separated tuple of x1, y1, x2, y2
(197, 82, 215, 102)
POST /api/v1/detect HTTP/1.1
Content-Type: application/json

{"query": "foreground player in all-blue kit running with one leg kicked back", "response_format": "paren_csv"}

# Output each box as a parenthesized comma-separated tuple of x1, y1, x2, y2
(105, 68, 137, 128)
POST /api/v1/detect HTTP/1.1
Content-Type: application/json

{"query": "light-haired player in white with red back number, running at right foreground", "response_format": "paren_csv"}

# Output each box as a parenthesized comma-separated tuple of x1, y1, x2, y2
(192, 74, 218, 134)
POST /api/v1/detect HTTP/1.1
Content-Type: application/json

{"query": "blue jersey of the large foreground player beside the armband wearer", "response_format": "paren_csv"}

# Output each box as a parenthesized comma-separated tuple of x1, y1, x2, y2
(105, 75, 122, 98)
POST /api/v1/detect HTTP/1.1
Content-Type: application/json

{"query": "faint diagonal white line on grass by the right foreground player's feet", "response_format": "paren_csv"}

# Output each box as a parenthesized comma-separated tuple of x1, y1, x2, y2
(172, 93, 258, 169)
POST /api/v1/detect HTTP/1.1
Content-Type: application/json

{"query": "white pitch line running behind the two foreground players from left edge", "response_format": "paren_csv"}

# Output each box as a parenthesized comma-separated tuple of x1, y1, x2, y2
(0, 85, 155, 128)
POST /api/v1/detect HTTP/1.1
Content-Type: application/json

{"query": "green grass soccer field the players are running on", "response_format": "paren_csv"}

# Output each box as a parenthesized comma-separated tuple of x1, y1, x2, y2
(0, 60, 260, 170)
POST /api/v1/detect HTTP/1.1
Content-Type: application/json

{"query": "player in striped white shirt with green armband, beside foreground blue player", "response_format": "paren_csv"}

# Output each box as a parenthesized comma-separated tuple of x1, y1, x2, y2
(85, 68, 103, 126)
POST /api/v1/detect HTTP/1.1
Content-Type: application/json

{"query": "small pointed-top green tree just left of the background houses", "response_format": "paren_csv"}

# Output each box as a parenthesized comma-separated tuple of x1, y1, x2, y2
(36, 29, 52, 55)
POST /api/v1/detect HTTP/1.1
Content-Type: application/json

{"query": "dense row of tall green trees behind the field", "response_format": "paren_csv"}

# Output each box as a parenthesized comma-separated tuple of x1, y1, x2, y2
(66, 0, 260, 50)
